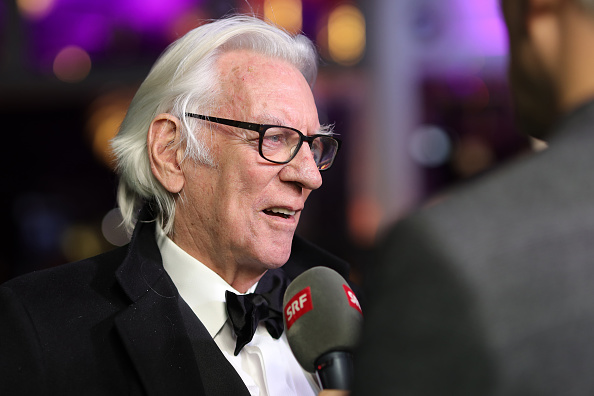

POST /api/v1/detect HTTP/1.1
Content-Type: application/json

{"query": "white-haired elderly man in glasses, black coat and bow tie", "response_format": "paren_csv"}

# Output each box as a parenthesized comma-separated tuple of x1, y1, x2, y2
(0, 17, 348, 395)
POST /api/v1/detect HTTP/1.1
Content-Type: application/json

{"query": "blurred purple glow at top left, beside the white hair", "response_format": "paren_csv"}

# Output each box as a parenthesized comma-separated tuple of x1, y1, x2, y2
(26, 0, 202, 71)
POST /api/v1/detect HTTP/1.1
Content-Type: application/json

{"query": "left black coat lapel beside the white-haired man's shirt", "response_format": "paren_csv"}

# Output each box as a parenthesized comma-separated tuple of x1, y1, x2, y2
(115, 215, 204, 396)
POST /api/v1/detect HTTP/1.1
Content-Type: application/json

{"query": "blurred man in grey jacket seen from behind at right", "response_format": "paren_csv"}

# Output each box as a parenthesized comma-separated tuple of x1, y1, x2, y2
(354, 0, 594, 396)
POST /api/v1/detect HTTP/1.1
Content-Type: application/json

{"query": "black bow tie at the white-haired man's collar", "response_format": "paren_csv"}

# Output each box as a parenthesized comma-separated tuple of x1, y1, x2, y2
(225, 268, 290, 356)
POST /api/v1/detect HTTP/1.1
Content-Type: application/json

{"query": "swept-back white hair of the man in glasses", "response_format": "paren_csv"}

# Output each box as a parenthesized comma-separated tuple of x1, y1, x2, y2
(112, 15, 318, 233)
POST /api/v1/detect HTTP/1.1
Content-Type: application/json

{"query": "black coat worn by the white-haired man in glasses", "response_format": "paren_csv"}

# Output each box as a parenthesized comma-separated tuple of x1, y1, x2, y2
(0, 209, 348, 396)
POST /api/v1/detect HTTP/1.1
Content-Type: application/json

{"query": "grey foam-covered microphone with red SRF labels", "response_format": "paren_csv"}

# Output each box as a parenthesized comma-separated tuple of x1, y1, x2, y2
(283, 267, 363, 390)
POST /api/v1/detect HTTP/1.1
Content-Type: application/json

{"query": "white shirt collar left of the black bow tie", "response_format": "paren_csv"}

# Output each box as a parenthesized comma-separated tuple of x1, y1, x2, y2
(157, 227, 257, 338)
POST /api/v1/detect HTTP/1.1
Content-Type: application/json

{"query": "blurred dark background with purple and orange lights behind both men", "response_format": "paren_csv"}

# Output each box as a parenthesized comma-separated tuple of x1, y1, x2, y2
(0, 0, 532, 283)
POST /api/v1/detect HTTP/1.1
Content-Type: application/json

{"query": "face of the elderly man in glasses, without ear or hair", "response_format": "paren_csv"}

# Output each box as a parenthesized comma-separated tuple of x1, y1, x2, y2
(175, 51, 322, 271)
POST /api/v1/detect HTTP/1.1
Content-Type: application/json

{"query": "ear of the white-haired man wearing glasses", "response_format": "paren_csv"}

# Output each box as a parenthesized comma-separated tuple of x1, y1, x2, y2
(146, 113, 185, 194)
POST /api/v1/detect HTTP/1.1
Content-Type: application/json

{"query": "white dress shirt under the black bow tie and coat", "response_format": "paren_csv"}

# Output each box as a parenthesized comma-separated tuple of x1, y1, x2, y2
(157, 227, 320, 396)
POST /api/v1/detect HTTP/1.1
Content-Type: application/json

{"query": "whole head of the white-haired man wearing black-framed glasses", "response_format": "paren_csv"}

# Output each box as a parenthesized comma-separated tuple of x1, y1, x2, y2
(113, 16, 335, 290)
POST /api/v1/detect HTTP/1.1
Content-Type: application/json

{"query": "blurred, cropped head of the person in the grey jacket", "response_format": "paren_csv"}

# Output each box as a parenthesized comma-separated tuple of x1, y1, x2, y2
(501, 0, 594, 137)
